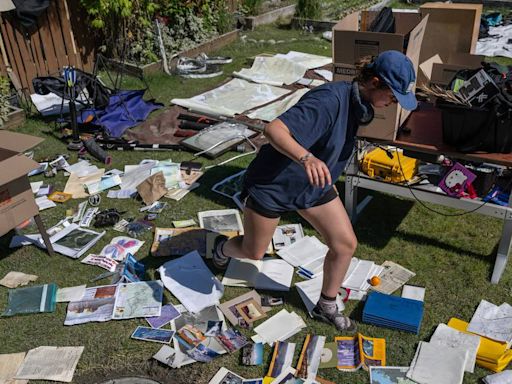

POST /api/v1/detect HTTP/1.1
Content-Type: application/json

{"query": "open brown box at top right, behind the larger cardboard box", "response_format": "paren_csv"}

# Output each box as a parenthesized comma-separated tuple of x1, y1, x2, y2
(420, 3, 482, 63)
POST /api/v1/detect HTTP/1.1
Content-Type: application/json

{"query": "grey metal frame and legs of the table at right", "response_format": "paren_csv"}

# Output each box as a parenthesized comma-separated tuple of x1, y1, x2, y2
(345, 142, 512, 284)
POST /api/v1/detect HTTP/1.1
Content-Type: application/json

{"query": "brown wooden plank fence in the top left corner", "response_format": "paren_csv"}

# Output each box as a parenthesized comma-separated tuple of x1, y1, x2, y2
(0, 0, 95, 93)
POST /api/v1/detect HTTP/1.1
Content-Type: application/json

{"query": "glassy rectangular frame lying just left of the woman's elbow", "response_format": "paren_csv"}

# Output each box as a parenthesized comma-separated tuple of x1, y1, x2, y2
(180, 121, 257, 159)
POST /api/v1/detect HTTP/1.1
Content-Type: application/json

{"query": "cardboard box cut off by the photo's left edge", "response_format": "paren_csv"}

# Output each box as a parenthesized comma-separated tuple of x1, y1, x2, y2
(0, 131, 43, 236)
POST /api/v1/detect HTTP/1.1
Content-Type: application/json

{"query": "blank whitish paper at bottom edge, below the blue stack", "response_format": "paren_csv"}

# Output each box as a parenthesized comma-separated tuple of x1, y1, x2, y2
(406, 341, 467, 384)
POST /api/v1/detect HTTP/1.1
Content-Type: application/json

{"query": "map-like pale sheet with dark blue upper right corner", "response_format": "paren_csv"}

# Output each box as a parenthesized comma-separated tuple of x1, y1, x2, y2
(112, 280, 163, 320)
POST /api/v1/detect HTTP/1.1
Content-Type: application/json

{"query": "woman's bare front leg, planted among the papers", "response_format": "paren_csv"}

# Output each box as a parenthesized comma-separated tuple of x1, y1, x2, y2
(299, 198, 357, 297)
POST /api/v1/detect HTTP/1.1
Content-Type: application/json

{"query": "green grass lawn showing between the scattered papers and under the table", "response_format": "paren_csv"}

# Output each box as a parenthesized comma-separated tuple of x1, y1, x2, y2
(0, 23, 512, 384)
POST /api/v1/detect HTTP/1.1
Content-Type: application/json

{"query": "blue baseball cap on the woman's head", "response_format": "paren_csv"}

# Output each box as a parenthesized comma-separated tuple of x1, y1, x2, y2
(369, 51, 418, 111)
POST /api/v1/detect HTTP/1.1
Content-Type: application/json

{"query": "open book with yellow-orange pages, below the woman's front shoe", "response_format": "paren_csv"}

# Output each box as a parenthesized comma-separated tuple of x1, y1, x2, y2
(335, 333, 386, 371)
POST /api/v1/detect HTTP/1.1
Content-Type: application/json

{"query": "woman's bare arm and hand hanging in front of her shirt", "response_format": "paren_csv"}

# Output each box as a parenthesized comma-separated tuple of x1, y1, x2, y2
(264, 119, 332, 188)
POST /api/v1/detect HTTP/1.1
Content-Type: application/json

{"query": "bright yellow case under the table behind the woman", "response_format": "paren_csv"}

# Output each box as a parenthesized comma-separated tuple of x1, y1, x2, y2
(361, 148, 419, 183)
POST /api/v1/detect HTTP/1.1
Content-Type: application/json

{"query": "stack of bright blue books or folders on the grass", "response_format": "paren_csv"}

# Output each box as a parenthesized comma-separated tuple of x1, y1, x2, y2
(363, 292, 423, 334)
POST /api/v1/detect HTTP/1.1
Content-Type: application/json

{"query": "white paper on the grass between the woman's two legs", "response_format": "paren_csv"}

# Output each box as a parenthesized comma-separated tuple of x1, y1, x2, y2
(277, 236, 329, 267)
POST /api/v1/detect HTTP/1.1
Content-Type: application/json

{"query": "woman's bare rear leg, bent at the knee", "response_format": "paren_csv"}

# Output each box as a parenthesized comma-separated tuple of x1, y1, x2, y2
(222, 208, 279, 260)
